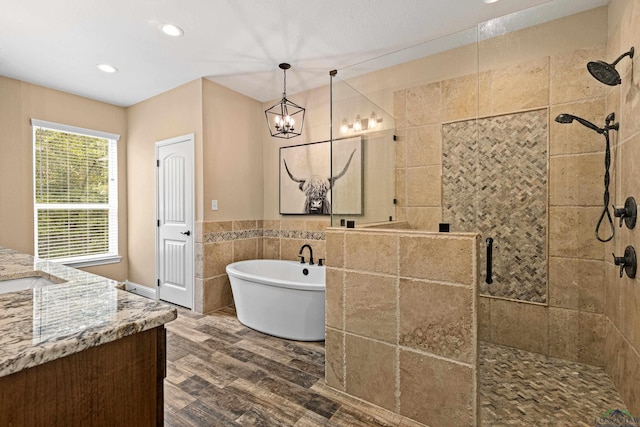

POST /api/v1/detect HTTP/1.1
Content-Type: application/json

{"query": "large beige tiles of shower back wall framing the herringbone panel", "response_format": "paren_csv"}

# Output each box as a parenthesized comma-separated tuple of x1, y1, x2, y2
(394, 44, 610, 366)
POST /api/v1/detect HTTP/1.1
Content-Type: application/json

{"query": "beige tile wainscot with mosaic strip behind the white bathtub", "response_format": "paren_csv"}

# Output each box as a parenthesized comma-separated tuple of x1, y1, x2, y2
(194, 219, 329, 313)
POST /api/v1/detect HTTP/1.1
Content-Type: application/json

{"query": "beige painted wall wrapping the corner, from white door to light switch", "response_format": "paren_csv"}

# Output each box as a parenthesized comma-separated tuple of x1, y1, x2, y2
(127, 79, 263, 286)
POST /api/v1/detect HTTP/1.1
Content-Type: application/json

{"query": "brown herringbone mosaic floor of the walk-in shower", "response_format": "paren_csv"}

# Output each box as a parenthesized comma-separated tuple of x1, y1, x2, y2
(479, 342, 624, 427)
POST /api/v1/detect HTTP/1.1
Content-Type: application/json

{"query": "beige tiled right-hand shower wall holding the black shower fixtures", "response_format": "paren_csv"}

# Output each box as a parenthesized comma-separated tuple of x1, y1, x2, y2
(603, 0, 640, 415)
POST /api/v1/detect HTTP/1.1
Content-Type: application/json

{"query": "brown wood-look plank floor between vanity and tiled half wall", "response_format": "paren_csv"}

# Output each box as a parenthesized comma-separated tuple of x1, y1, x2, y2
(165, 308, 422, 427)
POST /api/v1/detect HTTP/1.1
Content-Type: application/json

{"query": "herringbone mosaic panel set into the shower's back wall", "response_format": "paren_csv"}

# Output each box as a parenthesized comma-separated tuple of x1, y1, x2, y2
(443, 109, 548, 303)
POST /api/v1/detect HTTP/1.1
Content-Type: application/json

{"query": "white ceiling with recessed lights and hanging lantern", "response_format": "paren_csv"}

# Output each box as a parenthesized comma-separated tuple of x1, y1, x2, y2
(0, 0, 608, 106)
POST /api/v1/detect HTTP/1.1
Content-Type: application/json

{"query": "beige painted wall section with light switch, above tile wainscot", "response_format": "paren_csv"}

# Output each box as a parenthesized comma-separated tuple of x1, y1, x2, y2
(202, 79, 265, 221)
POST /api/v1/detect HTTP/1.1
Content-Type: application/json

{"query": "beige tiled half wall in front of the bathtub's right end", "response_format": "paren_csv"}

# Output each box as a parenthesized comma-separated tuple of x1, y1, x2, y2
(326, 228, 479, 425)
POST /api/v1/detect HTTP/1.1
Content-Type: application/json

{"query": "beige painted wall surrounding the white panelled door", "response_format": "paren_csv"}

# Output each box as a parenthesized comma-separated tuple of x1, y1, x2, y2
(127, 79, 203, 286)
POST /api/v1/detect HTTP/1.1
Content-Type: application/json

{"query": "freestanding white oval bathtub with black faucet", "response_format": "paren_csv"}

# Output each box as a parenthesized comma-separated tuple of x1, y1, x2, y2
(227, 259, 326, 341)
